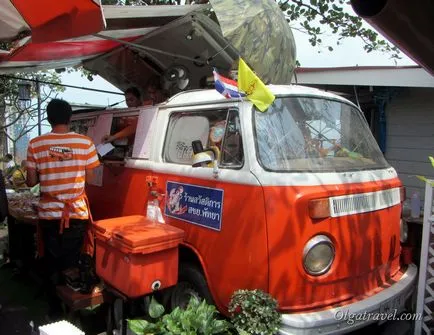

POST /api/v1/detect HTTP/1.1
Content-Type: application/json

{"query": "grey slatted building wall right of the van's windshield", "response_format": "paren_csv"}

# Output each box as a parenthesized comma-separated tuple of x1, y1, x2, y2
(385, 88, 434, 198)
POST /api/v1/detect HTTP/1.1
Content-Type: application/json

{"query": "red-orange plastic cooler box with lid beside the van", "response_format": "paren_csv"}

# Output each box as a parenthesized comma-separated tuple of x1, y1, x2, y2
(94, 215, 184, 298)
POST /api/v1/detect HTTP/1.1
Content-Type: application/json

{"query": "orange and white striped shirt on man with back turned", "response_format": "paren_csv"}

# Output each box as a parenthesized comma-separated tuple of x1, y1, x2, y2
(27, 132, 99, 220)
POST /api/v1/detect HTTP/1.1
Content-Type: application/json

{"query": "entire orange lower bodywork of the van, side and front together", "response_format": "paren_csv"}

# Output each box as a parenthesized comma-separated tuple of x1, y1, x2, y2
(87, 166, 401, 313)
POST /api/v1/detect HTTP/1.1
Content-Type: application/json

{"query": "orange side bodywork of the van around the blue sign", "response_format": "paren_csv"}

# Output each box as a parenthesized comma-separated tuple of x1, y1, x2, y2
(87, 167, 269, 311)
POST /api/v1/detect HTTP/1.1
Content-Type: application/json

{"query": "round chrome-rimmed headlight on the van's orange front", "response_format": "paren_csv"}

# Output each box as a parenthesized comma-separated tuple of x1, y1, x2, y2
(303, 235, 335, 276)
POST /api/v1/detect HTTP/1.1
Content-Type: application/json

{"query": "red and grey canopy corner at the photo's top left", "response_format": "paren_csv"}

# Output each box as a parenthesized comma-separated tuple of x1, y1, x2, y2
(0, 0, 105, 43)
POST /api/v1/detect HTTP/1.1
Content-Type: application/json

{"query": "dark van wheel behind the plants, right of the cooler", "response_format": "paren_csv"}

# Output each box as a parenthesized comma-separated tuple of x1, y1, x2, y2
(170, 263, 213, 310)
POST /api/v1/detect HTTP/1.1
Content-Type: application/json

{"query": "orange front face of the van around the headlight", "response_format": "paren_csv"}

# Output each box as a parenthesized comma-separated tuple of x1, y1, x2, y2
(264, 179, 401, 311)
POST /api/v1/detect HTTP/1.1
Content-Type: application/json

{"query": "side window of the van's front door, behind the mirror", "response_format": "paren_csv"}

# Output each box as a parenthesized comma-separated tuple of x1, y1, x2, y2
(163, 109, 244, 168)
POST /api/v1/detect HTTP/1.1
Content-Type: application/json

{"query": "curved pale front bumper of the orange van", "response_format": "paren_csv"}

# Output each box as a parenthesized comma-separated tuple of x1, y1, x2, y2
(279, 264, 417, 335)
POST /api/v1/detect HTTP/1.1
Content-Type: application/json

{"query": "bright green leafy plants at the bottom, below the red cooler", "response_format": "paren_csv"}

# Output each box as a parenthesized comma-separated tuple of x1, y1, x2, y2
(128, 297, 231, 335)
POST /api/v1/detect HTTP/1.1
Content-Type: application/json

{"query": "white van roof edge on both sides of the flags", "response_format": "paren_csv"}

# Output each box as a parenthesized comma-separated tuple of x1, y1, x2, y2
(164, 85, 351, 107)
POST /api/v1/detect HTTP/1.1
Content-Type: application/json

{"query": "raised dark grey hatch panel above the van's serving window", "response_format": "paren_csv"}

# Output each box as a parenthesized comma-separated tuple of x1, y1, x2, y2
(79, 11, 238, 95)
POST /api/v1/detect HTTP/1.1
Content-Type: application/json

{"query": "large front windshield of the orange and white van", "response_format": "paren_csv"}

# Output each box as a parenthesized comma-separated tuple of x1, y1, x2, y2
(254, 97, 388, 172)
